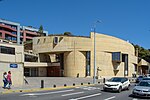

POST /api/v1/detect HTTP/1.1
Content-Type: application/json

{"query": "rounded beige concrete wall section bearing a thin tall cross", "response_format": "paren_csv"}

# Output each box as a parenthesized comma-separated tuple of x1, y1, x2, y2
(64, 51, 86, 77)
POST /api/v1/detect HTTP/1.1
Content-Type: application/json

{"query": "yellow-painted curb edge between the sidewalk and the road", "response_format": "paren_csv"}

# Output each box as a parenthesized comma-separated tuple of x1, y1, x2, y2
(0, 84, 100, 94)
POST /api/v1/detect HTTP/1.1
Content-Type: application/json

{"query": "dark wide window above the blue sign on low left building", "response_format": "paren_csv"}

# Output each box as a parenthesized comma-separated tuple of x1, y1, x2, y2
(0, 46, 15, 55)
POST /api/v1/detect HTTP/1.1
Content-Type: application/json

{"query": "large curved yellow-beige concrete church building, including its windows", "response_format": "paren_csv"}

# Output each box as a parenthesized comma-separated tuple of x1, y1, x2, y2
(33, 32, 146, 77)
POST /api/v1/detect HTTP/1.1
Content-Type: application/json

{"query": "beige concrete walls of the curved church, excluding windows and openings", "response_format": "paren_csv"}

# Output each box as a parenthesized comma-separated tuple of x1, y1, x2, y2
(33, 33, 137, 77)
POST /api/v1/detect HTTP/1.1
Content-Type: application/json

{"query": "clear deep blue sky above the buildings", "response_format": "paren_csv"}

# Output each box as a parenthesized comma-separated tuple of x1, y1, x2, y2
(0, 0, 150, 49)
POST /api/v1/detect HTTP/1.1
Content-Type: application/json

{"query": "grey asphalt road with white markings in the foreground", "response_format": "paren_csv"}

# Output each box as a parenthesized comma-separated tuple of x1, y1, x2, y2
(0, 84, 148, 100)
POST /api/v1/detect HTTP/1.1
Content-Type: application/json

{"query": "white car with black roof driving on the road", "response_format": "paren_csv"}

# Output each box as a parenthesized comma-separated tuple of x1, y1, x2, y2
(103, 77, 130, 92)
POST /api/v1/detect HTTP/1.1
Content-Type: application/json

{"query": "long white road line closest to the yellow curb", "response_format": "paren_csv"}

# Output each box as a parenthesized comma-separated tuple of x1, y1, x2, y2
(20, 89, 74, 96)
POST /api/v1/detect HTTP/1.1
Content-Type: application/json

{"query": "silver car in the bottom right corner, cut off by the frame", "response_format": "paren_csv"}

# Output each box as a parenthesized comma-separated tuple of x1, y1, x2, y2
(132, 80, 150, 97)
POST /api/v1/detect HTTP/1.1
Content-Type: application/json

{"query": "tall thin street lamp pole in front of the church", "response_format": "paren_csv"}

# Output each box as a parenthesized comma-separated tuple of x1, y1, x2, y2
(93, 20, 101, 84)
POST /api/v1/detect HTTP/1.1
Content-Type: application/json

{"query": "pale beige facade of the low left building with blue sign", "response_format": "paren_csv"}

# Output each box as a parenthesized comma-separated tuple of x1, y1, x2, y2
(0, 42, 24, 86)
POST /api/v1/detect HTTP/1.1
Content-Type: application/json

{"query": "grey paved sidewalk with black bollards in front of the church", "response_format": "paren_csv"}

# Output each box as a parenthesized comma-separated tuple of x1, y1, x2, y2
(0, 77, 103, 94)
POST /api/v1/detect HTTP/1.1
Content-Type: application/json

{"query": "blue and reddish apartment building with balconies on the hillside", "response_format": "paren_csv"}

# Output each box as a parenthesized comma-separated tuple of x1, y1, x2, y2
(0, 19, 48, 44)
